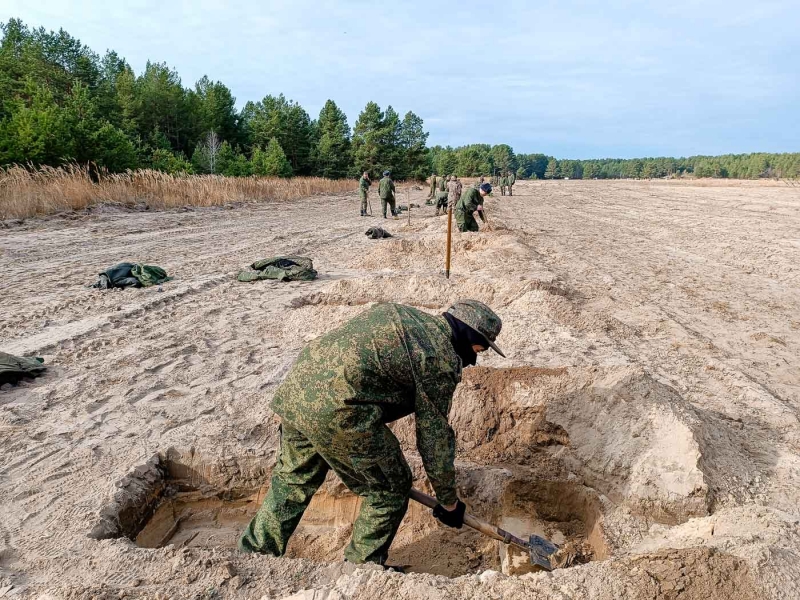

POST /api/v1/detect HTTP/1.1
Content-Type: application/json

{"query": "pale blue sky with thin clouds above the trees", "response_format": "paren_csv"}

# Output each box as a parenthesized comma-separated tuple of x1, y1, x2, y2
(0, 0, 800, 158)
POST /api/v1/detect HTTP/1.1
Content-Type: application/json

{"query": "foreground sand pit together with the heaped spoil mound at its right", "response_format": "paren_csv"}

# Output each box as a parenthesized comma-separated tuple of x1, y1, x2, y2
(92, 367, 707, 577)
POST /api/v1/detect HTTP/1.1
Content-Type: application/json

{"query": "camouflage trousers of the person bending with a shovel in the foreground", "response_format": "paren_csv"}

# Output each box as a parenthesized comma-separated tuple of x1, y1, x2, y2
(239, 404, 411, 564)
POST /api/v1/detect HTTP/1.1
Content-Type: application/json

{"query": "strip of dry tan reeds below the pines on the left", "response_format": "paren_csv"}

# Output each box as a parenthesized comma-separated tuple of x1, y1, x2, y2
(0, 165, 358, 221)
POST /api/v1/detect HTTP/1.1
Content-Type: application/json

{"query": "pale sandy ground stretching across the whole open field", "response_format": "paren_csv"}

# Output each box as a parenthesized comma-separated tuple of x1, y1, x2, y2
(0, 181, 800, 600)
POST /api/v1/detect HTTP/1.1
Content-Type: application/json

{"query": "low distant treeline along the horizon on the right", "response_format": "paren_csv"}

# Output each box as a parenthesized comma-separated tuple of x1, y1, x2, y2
(430, 144, 800, 179)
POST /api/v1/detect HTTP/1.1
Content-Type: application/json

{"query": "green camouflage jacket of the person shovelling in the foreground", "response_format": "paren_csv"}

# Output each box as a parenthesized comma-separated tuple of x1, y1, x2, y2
(272, 304, 462, 504)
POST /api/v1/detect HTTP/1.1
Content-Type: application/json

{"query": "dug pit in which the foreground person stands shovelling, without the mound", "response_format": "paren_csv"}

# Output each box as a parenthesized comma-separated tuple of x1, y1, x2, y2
(92, 451, 609, 577)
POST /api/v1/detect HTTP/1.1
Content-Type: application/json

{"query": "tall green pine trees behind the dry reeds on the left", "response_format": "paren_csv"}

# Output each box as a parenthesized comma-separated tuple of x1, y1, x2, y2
(0, 19, 430, 179)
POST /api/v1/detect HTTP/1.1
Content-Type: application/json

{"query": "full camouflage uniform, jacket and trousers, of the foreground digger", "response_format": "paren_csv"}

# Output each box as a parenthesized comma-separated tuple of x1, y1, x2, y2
(239, 304, 460, 564)
